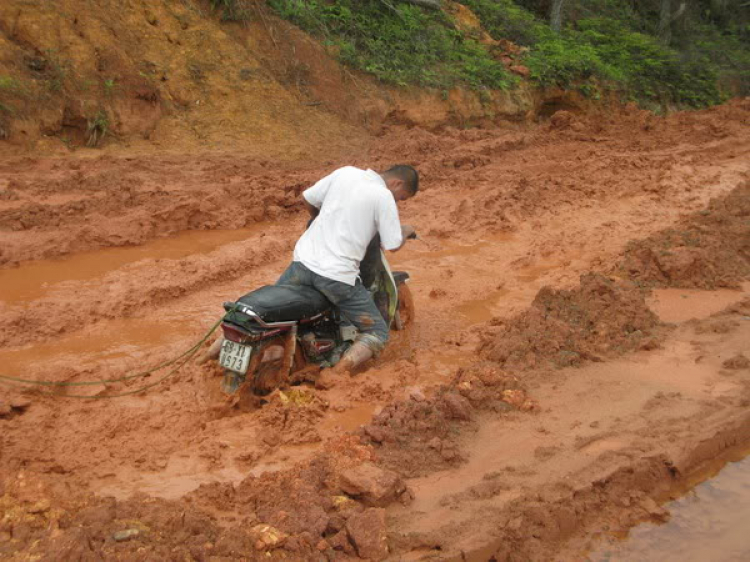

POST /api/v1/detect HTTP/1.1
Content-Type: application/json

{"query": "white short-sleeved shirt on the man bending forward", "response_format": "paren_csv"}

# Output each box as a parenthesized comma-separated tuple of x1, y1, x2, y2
(294, 166, 402, 285)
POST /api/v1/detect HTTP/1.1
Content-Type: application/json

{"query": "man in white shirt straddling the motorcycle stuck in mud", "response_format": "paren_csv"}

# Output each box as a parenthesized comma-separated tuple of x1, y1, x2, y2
(276, 165, 419, 374)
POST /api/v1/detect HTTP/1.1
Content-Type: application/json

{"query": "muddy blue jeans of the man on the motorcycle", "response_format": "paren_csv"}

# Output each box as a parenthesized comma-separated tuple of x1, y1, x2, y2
(276, 261, 388, 353)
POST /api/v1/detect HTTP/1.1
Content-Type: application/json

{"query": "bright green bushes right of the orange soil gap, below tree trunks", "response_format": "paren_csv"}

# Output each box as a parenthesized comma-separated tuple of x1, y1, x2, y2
(464, 0, 722, 107)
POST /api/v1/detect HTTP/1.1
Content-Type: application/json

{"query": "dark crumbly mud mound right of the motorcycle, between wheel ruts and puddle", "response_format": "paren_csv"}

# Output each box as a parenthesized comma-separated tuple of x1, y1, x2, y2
(479, 273, 659, 369)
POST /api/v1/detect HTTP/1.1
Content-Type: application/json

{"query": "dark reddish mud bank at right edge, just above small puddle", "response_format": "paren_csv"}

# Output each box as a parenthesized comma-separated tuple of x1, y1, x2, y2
(619, 182, 750, 289)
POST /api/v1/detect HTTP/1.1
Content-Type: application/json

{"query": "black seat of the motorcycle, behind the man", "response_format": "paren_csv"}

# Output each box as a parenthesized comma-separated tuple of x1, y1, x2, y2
(237, 285, 331, 322)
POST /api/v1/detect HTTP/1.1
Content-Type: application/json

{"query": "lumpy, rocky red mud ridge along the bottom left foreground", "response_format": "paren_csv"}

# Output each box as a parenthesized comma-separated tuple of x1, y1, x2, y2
(0, 436, 408, 560)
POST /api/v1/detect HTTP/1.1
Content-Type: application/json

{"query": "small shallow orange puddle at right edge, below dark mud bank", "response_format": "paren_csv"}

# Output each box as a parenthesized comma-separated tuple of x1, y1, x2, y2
(648, 283, 750, 323)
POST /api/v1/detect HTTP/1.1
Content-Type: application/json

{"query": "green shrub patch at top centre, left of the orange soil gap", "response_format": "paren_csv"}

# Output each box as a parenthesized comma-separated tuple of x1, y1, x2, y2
(269, 0, 513, 89)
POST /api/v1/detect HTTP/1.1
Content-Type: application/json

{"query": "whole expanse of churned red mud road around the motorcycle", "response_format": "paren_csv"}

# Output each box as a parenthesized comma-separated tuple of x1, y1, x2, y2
(0, 101, 750, 560)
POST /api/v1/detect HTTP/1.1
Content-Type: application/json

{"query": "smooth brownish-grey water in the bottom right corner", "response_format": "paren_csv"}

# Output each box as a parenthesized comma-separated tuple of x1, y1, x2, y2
(588, 451, 750, 562)
